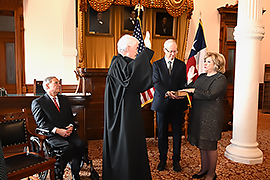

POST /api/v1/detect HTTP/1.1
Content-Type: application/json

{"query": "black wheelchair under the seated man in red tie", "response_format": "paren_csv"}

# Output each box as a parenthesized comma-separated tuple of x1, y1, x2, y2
(30, 128, 99, 180)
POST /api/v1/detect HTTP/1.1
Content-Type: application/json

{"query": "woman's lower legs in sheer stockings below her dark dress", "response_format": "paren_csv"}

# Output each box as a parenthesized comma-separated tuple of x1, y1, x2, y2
(198, 150, 218, 180)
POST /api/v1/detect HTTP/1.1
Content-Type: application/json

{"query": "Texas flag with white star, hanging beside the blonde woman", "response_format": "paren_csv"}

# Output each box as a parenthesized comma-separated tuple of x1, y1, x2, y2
(186, 19, 207, 81)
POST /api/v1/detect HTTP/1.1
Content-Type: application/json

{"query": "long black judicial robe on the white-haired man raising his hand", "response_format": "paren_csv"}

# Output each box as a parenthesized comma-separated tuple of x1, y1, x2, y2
(102, 48, 154, 180)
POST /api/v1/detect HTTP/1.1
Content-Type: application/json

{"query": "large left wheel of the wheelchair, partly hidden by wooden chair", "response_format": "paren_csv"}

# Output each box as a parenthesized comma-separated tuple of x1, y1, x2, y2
(30, 136, 49, 180)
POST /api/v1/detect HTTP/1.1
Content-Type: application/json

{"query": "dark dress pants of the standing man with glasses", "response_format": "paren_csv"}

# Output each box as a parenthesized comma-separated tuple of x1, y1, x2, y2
(157, 110, 183, 162)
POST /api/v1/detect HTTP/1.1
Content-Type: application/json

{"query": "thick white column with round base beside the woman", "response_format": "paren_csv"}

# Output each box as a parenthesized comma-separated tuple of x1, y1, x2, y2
(225, 0, 264, 164)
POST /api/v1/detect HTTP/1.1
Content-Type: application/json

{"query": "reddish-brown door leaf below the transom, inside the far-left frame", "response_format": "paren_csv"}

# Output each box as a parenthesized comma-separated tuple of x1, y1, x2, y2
(0, 32, 17, 94)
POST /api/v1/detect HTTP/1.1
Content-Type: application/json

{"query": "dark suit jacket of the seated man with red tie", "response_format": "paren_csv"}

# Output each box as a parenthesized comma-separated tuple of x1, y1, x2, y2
(31, 93, 75, 135)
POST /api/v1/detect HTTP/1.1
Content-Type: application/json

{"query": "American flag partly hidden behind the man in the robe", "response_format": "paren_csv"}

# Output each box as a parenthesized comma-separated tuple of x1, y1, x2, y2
(133, 18, 155, 107)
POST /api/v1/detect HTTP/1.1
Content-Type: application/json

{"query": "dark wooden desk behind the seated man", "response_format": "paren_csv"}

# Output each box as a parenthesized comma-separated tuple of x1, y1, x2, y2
(0, 93, 91, 142)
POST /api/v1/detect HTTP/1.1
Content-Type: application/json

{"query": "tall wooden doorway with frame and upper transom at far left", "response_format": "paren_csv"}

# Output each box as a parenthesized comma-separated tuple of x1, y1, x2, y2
(0, 0, 26, 94)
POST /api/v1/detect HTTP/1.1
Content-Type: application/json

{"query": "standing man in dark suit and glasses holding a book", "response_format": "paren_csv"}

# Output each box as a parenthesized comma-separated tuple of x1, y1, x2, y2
(151, 39, 187, 172)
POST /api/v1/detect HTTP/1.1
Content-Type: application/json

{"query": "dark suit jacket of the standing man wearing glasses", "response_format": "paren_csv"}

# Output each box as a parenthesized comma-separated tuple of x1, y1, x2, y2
(151, 58, 187, 112)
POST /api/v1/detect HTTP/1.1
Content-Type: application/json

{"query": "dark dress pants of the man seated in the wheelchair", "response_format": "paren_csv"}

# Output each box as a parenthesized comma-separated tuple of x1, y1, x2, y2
(48, 133, 86, 175)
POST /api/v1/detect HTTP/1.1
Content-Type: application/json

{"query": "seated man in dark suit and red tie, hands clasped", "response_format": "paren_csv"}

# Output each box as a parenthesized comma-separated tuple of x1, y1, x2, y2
(31, 76, 86, 180)
